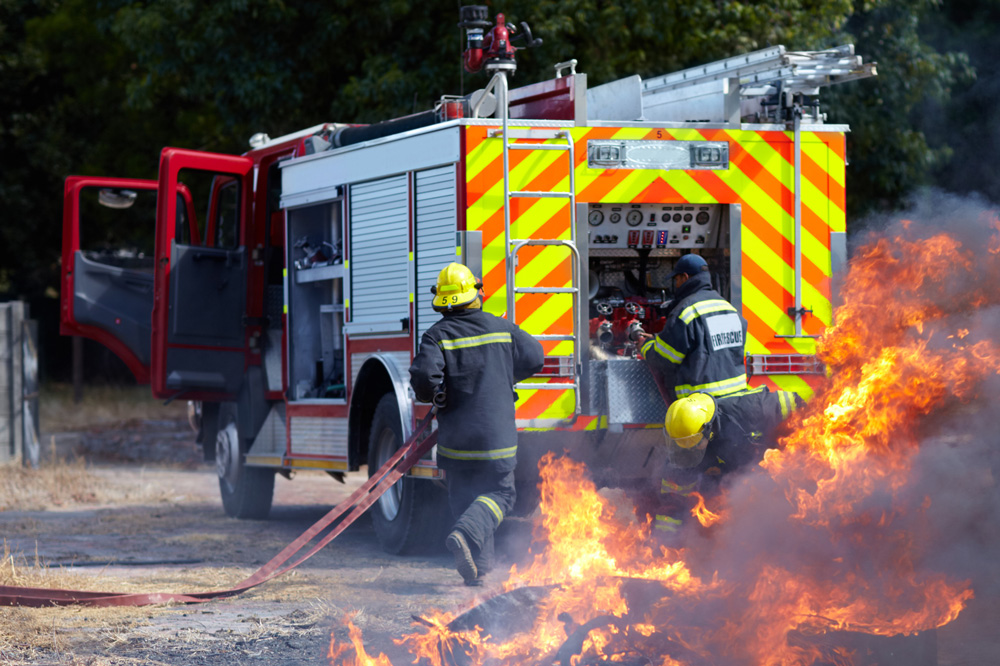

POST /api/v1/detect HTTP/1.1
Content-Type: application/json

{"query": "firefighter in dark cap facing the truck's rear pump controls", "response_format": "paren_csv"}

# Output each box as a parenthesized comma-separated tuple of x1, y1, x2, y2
(640, 254, 747, 405)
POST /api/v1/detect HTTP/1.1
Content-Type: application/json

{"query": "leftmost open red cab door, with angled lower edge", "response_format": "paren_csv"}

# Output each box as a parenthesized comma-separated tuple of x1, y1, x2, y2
(59, 176, 164, 384)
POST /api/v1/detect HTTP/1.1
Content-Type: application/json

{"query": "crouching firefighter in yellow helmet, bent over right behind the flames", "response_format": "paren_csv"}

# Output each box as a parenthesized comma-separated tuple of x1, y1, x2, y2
(655, 386, 802, 534)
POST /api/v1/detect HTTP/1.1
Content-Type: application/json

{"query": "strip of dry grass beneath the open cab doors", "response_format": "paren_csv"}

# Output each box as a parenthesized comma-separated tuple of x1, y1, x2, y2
(38, 383, 187, 433)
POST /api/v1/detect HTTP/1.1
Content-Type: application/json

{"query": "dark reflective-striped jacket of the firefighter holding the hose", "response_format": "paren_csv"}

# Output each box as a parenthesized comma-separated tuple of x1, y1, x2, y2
(410, 309, 545, 472)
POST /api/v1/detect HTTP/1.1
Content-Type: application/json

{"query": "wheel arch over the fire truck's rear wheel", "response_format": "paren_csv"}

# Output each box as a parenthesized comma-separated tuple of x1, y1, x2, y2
(348, 354, 413, 470)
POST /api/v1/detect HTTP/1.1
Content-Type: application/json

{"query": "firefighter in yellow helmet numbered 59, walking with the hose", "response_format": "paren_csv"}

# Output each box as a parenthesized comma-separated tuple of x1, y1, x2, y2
(410, 263, 544, 585)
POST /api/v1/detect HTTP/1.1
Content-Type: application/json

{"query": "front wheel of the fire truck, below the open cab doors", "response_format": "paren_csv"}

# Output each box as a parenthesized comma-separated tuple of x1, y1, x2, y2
(215, 403, 274, 520)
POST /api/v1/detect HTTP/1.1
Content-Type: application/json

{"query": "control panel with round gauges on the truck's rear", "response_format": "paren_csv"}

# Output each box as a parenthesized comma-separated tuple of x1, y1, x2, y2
(587, 204, 722, 254)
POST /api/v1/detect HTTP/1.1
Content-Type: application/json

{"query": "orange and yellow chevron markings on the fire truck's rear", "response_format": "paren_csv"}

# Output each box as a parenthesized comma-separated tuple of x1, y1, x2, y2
(466, 120, 845, 410)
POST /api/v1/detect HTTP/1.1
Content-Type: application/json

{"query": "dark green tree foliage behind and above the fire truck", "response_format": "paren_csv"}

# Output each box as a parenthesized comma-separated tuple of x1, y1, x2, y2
(0, 0, 984, 308)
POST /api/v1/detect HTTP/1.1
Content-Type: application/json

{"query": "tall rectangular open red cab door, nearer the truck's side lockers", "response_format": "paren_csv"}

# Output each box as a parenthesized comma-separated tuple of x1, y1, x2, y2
(151, 148, 253, 401)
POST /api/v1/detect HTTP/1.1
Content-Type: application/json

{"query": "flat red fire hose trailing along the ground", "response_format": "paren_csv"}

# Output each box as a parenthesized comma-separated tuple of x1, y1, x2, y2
(0, 407, 437, 608)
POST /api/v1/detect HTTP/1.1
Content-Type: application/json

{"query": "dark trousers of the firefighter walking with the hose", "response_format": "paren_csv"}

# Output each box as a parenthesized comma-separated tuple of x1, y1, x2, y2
(446, 470, 517, 573)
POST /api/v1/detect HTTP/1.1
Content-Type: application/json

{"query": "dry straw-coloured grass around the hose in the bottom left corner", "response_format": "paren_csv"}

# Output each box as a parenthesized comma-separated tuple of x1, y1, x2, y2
(0, 543, 341, 666)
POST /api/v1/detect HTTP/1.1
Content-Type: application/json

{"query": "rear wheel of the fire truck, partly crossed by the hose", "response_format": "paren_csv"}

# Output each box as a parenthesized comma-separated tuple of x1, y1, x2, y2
(368, 393, 451, 555)
